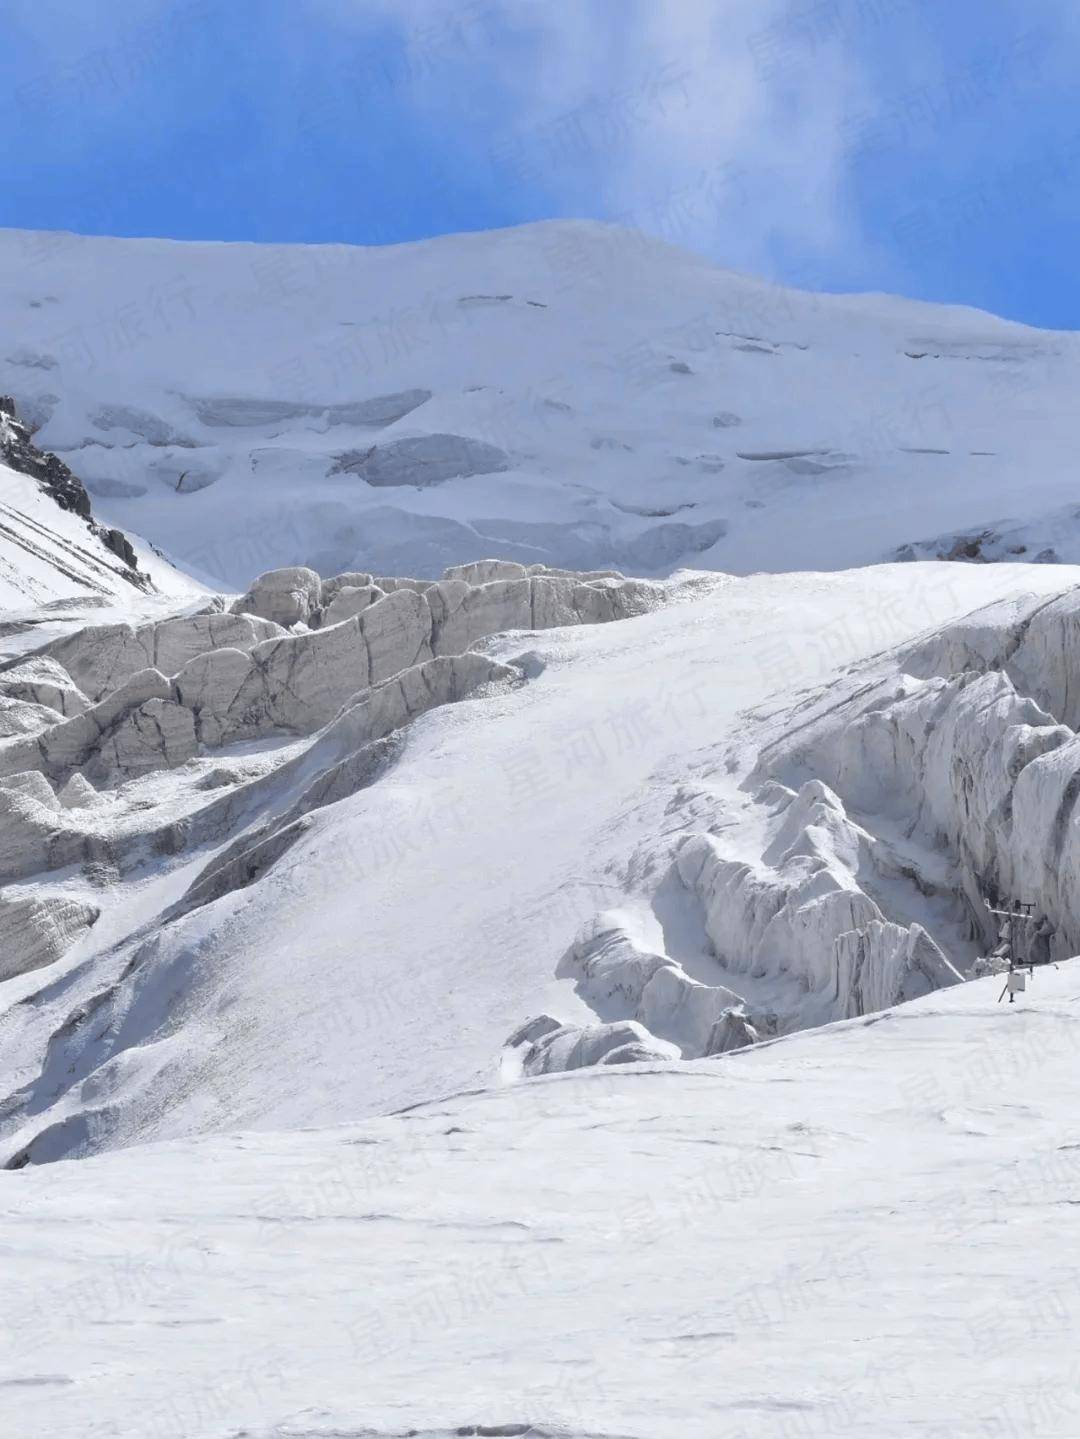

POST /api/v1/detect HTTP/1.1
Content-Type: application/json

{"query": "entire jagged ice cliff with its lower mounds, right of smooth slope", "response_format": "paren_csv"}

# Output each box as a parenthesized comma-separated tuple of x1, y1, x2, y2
(511, 589, 1080, 1073)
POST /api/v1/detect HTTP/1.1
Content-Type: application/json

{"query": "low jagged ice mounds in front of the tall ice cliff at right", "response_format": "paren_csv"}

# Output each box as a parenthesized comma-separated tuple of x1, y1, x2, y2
(509, 781, 964, 1075)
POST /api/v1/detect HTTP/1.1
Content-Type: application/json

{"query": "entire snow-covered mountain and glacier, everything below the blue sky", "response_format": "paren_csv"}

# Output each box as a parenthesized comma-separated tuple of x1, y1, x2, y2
(0, 224, 1080, 1439)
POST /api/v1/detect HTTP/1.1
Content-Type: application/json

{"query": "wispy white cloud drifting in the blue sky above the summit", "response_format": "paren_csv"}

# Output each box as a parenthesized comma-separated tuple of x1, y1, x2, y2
(316, 0, 876, 273)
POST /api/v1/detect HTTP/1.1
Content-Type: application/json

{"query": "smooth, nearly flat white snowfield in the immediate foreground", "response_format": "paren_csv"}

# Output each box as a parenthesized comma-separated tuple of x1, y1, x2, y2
(0, 961, 1080, 1439)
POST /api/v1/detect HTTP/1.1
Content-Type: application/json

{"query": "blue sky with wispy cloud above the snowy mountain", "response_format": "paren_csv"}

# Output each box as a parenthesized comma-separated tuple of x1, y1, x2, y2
(0, 0, 1080, 328)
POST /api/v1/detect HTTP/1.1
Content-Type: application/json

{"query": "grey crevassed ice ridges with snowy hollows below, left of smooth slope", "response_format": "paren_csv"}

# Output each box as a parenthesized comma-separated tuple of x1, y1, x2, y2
(0, 560, 667, 1013)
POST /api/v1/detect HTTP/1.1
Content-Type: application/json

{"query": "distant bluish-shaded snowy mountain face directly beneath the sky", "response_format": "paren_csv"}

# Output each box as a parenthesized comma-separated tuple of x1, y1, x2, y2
(0, 223, 1080, 587)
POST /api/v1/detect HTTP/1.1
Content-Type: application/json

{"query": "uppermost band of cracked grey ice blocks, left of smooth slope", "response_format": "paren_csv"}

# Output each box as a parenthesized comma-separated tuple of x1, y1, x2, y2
(0, 561, 663, 789)
